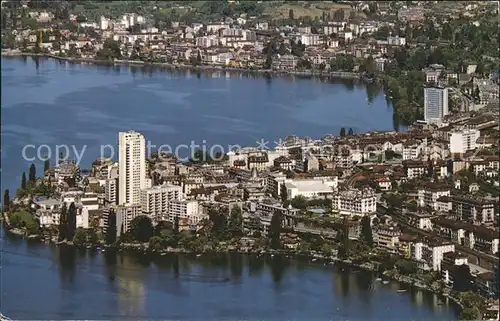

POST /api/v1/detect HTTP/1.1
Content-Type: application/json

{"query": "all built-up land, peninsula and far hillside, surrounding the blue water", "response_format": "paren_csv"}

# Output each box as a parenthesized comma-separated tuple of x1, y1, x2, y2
(2, 1, 500, 320)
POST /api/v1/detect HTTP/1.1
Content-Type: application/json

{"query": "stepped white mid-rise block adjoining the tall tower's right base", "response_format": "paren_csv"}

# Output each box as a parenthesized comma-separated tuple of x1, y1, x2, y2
(141, 184, 182, 222)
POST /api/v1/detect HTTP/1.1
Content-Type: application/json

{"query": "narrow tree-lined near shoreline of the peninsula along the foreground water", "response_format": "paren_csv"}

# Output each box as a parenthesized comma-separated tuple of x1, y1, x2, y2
(4, 222, 464, 311)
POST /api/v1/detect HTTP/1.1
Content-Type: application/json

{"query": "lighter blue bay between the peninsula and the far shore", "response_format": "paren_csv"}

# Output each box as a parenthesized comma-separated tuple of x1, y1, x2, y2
(1, 57, 397, 195)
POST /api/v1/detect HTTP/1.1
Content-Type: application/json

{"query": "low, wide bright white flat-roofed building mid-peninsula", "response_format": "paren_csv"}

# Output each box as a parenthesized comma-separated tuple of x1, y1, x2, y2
(284, 176, 338, 199)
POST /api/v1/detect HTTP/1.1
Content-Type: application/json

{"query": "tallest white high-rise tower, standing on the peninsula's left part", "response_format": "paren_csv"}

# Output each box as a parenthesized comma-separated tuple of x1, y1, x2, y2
(118, 131, 146, 205)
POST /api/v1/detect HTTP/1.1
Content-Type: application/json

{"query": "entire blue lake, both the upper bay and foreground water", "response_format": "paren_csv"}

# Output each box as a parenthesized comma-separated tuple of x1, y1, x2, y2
(1, 58, 450, 320)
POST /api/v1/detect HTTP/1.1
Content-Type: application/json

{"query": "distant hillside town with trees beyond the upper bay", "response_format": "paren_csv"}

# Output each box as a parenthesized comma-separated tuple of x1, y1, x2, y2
(2, 0, 499, 124)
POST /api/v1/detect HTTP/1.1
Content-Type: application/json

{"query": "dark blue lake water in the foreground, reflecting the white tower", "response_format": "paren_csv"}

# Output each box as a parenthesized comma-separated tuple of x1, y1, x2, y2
(1, 231, 457, 321)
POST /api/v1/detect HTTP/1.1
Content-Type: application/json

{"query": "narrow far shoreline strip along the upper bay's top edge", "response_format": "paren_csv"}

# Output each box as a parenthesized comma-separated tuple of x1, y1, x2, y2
(2, 51, 368, 81)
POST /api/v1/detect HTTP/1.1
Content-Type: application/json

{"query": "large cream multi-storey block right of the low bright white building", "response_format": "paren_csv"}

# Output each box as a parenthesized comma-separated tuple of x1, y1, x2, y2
(332, 188, 377, 215)
